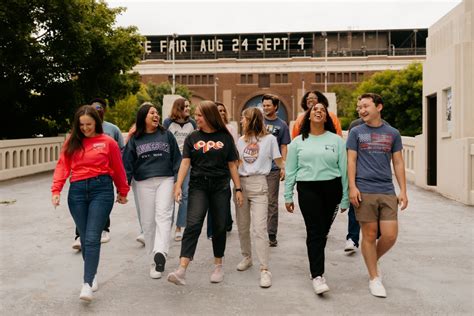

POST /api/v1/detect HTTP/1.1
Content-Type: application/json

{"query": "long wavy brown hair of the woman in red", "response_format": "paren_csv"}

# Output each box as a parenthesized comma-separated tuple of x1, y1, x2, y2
(64, 105, 104, 157)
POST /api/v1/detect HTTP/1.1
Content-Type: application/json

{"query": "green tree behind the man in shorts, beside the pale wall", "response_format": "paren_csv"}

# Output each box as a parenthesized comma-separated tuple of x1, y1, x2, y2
(353, 63, 423, 136)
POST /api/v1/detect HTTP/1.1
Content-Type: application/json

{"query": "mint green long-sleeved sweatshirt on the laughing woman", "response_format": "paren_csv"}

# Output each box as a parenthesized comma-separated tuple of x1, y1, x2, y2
(285, 132, 349, 208)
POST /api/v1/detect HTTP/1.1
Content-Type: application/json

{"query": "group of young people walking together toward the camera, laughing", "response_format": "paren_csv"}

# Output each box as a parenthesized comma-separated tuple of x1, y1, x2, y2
(52, 91, 408, 301)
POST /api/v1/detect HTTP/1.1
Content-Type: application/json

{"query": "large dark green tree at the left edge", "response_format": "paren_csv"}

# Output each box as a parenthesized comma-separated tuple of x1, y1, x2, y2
(0, 0, 143, 138)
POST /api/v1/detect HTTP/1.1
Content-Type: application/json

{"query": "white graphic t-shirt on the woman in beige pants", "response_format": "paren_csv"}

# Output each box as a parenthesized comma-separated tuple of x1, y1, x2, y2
(237, 134, 281, 176)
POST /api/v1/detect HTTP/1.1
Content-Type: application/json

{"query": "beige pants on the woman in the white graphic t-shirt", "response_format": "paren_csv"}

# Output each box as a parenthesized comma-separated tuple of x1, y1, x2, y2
(234, 175, 270, 270)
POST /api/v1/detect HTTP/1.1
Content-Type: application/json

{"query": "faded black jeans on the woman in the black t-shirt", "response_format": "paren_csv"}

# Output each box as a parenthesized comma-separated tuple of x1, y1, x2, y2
(181, 176, 231, 260)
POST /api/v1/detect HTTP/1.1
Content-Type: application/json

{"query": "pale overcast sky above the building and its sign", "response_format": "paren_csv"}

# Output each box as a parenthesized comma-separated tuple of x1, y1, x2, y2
(106, 0, 462, 35)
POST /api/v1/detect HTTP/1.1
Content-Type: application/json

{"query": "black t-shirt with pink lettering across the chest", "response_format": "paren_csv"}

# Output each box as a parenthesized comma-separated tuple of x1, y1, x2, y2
(183, 131, 239, 177)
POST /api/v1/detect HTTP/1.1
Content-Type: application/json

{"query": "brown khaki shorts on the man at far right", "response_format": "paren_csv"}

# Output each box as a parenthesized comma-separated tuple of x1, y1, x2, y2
(354, 193, 398, 222)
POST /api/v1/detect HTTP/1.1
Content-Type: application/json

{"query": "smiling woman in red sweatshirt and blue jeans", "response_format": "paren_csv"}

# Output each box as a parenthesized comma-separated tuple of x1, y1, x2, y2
(51, 105, 130, 301)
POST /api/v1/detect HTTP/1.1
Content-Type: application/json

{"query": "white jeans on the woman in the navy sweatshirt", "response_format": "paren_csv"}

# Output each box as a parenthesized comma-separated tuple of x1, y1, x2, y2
(136, 177, 174, 262)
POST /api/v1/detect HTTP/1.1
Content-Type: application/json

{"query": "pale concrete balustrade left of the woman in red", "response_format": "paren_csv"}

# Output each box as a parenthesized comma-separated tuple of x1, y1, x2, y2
(0, 137, 65, 181)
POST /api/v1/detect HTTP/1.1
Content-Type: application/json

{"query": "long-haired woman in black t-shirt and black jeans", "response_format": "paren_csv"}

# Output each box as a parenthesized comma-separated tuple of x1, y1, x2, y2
(168, 101, 243, 285)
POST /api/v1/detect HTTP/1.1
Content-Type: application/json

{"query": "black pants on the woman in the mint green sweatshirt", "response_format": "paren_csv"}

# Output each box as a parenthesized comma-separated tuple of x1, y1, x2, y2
(296, 178, 342, 278)
